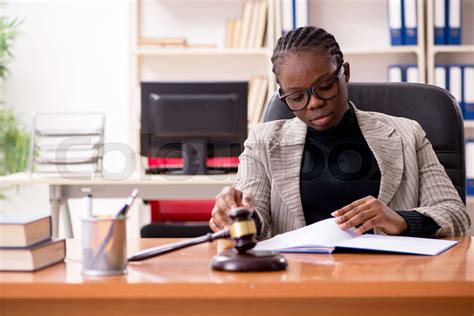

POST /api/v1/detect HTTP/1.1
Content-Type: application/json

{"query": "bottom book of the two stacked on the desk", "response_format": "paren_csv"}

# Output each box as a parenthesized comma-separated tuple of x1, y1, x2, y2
(0, 239, 66, 271)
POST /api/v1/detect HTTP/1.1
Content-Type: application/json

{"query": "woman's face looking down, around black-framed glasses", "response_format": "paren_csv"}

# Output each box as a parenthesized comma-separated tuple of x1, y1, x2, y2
(277, 49, 350, 131)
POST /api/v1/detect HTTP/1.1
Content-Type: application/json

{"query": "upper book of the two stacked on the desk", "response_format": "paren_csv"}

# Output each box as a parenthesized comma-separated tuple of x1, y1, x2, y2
(0, 214, 51, 247)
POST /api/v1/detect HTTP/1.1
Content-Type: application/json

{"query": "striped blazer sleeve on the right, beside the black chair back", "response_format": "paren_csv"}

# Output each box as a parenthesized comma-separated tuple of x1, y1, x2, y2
(414, 123, 471, 236)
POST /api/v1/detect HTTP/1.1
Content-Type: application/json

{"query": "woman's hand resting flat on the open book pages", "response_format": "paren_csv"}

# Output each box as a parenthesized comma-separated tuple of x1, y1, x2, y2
(331, 196, 408, 235)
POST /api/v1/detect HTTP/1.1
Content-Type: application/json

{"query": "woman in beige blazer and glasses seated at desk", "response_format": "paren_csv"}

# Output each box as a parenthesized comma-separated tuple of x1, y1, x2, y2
(209, 26, 470, 239)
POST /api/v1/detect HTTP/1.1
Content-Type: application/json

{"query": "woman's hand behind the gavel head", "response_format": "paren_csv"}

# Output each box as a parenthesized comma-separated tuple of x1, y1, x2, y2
(209, 187, 255, 232)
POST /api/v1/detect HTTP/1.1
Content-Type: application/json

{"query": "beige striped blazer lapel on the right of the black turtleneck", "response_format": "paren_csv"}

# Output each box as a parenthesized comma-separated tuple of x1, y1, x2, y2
(355, 109, 404, 204)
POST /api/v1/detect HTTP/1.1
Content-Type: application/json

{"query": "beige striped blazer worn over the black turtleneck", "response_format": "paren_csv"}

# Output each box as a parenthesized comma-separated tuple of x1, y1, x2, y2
(234, 109, 470, 239)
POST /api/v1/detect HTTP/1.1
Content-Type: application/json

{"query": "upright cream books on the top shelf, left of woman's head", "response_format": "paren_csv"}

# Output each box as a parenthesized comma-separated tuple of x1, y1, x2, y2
(225, 0, 268, 48)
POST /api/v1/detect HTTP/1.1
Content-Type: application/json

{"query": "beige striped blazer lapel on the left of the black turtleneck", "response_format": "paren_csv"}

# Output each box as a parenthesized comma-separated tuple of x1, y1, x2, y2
(269, 118, 307, 227)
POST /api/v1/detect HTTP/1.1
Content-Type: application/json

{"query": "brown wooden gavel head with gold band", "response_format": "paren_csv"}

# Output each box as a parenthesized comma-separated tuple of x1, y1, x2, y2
(229, 207, 257, 253)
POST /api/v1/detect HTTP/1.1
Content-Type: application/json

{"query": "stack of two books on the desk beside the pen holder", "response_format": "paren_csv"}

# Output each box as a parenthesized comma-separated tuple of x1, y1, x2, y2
(0, 213, 66, 271)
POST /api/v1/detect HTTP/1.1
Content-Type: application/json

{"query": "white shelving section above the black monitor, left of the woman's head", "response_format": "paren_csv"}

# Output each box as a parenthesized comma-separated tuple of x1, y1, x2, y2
(130, 0, 276, 158)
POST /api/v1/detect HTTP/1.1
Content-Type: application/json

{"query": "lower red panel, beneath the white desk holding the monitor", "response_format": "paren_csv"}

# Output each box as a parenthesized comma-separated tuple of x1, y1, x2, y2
(149, 200, 214, 222)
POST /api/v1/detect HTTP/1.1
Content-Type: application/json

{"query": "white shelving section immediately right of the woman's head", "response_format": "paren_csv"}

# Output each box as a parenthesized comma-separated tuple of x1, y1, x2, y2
(284, 0, 426, 83)
